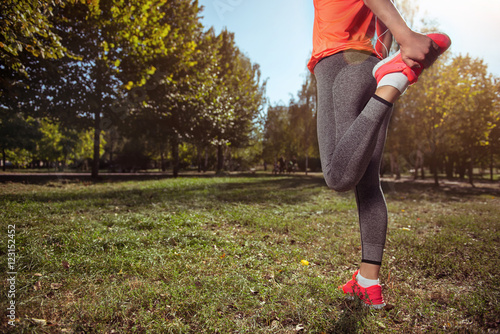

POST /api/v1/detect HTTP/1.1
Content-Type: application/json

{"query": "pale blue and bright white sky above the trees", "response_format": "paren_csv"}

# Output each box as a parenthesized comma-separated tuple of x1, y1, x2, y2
(199, 0, 500, 105)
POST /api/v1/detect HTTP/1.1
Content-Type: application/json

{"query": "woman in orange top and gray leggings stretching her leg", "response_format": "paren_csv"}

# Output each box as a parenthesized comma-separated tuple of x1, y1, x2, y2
(308, 0, 451, 308)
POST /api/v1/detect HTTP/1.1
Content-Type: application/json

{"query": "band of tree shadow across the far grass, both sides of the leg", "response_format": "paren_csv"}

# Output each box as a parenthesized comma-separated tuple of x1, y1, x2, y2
(0, 174, 500, 207)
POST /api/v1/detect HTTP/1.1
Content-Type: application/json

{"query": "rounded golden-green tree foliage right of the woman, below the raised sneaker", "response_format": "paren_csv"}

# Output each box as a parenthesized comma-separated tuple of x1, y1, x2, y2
(388, 56, 500, 182)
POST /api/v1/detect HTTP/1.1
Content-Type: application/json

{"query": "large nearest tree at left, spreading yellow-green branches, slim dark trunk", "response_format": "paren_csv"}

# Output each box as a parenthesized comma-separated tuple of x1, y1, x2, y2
(22, 0, 204, 177)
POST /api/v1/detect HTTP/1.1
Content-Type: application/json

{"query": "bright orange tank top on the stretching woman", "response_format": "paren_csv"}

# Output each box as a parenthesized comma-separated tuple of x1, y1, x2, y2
(307, 0, 375, 73)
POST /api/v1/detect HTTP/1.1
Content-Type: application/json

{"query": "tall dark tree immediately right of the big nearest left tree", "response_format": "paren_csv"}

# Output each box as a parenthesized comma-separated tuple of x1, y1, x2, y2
(127, 1, 209, 176)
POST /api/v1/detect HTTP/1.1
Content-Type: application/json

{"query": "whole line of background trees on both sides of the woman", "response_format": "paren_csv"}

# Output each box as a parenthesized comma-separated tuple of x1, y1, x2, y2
(0, 0, 500, 184)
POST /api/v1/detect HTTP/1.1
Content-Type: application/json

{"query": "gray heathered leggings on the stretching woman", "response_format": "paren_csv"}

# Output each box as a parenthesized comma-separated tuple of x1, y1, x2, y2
(314, 51, 392, 265)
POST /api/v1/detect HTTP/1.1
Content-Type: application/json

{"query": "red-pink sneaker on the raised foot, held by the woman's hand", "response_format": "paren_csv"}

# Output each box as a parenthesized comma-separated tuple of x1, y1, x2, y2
(373, 33, 451, 85)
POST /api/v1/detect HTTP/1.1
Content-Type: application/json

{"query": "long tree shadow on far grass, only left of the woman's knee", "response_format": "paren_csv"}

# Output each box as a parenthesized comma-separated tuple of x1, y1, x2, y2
(0, 175, 325, 207)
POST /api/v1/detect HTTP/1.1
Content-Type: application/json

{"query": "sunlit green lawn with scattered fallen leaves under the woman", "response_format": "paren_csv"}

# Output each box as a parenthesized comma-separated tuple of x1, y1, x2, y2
(0, 175, 500, 333)
